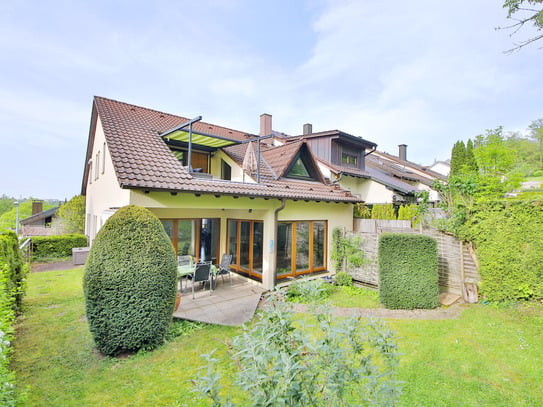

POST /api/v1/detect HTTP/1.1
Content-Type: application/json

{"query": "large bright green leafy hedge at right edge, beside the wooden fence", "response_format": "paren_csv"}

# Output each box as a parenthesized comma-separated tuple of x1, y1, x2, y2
(468, 199, 543, 301)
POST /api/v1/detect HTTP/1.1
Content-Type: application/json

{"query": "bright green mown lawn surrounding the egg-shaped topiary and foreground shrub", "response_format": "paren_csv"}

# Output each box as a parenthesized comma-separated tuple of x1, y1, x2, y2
(14, 269, 543, 406)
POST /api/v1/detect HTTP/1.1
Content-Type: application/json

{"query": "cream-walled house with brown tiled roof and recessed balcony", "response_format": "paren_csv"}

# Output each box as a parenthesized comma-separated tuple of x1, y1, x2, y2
(81, 97, 364, 289)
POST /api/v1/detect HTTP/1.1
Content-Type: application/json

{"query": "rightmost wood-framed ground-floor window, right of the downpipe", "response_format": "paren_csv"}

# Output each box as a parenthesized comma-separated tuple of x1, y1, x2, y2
(277, 221, 326, 278)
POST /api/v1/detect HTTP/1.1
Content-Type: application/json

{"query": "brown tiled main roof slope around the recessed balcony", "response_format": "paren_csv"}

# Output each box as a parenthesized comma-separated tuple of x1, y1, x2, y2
(86, 97, 358, 202)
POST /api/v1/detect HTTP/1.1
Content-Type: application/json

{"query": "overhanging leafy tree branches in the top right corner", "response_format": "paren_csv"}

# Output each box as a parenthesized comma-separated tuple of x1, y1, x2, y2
(500, 0, 543, 52)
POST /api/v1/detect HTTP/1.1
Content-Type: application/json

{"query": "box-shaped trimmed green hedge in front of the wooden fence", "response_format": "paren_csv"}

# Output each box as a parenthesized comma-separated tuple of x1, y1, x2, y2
(378, 233, 439, 309)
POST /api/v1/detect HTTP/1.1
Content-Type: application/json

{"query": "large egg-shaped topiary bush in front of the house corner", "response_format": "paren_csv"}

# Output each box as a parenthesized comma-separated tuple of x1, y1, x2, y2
(83, 205, 177, 356)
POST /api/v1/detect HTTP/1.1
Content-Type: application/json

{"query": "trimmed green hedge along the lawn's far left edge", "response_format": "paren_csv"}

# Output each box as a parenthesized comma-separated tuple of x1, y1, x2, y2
(0, 231, 28, 406)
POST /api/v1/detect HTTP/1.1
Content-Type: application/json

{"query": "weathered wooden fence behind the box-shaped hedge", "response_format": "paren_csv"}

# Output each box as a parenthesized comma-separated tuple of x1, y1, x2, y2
(350, 219, 480, 302)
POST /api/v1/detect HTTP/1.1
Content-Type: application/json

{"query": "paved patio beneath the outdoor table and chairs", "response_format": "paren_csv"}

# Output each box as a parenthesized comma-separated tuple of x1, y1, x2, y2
(173, 273, 264, 326)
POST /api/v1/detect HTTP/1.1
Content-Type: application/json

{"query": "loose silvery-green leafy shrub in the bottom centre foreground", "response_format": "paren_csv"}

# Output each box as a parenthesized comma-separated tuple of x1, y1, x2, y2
(194, 286, 401, 406)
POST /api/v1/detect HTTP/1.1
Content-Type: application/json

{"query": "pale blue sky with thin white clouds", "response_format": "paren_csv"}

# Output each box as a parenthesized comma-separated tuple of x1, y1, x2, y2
(0, 0, 543, 200)
